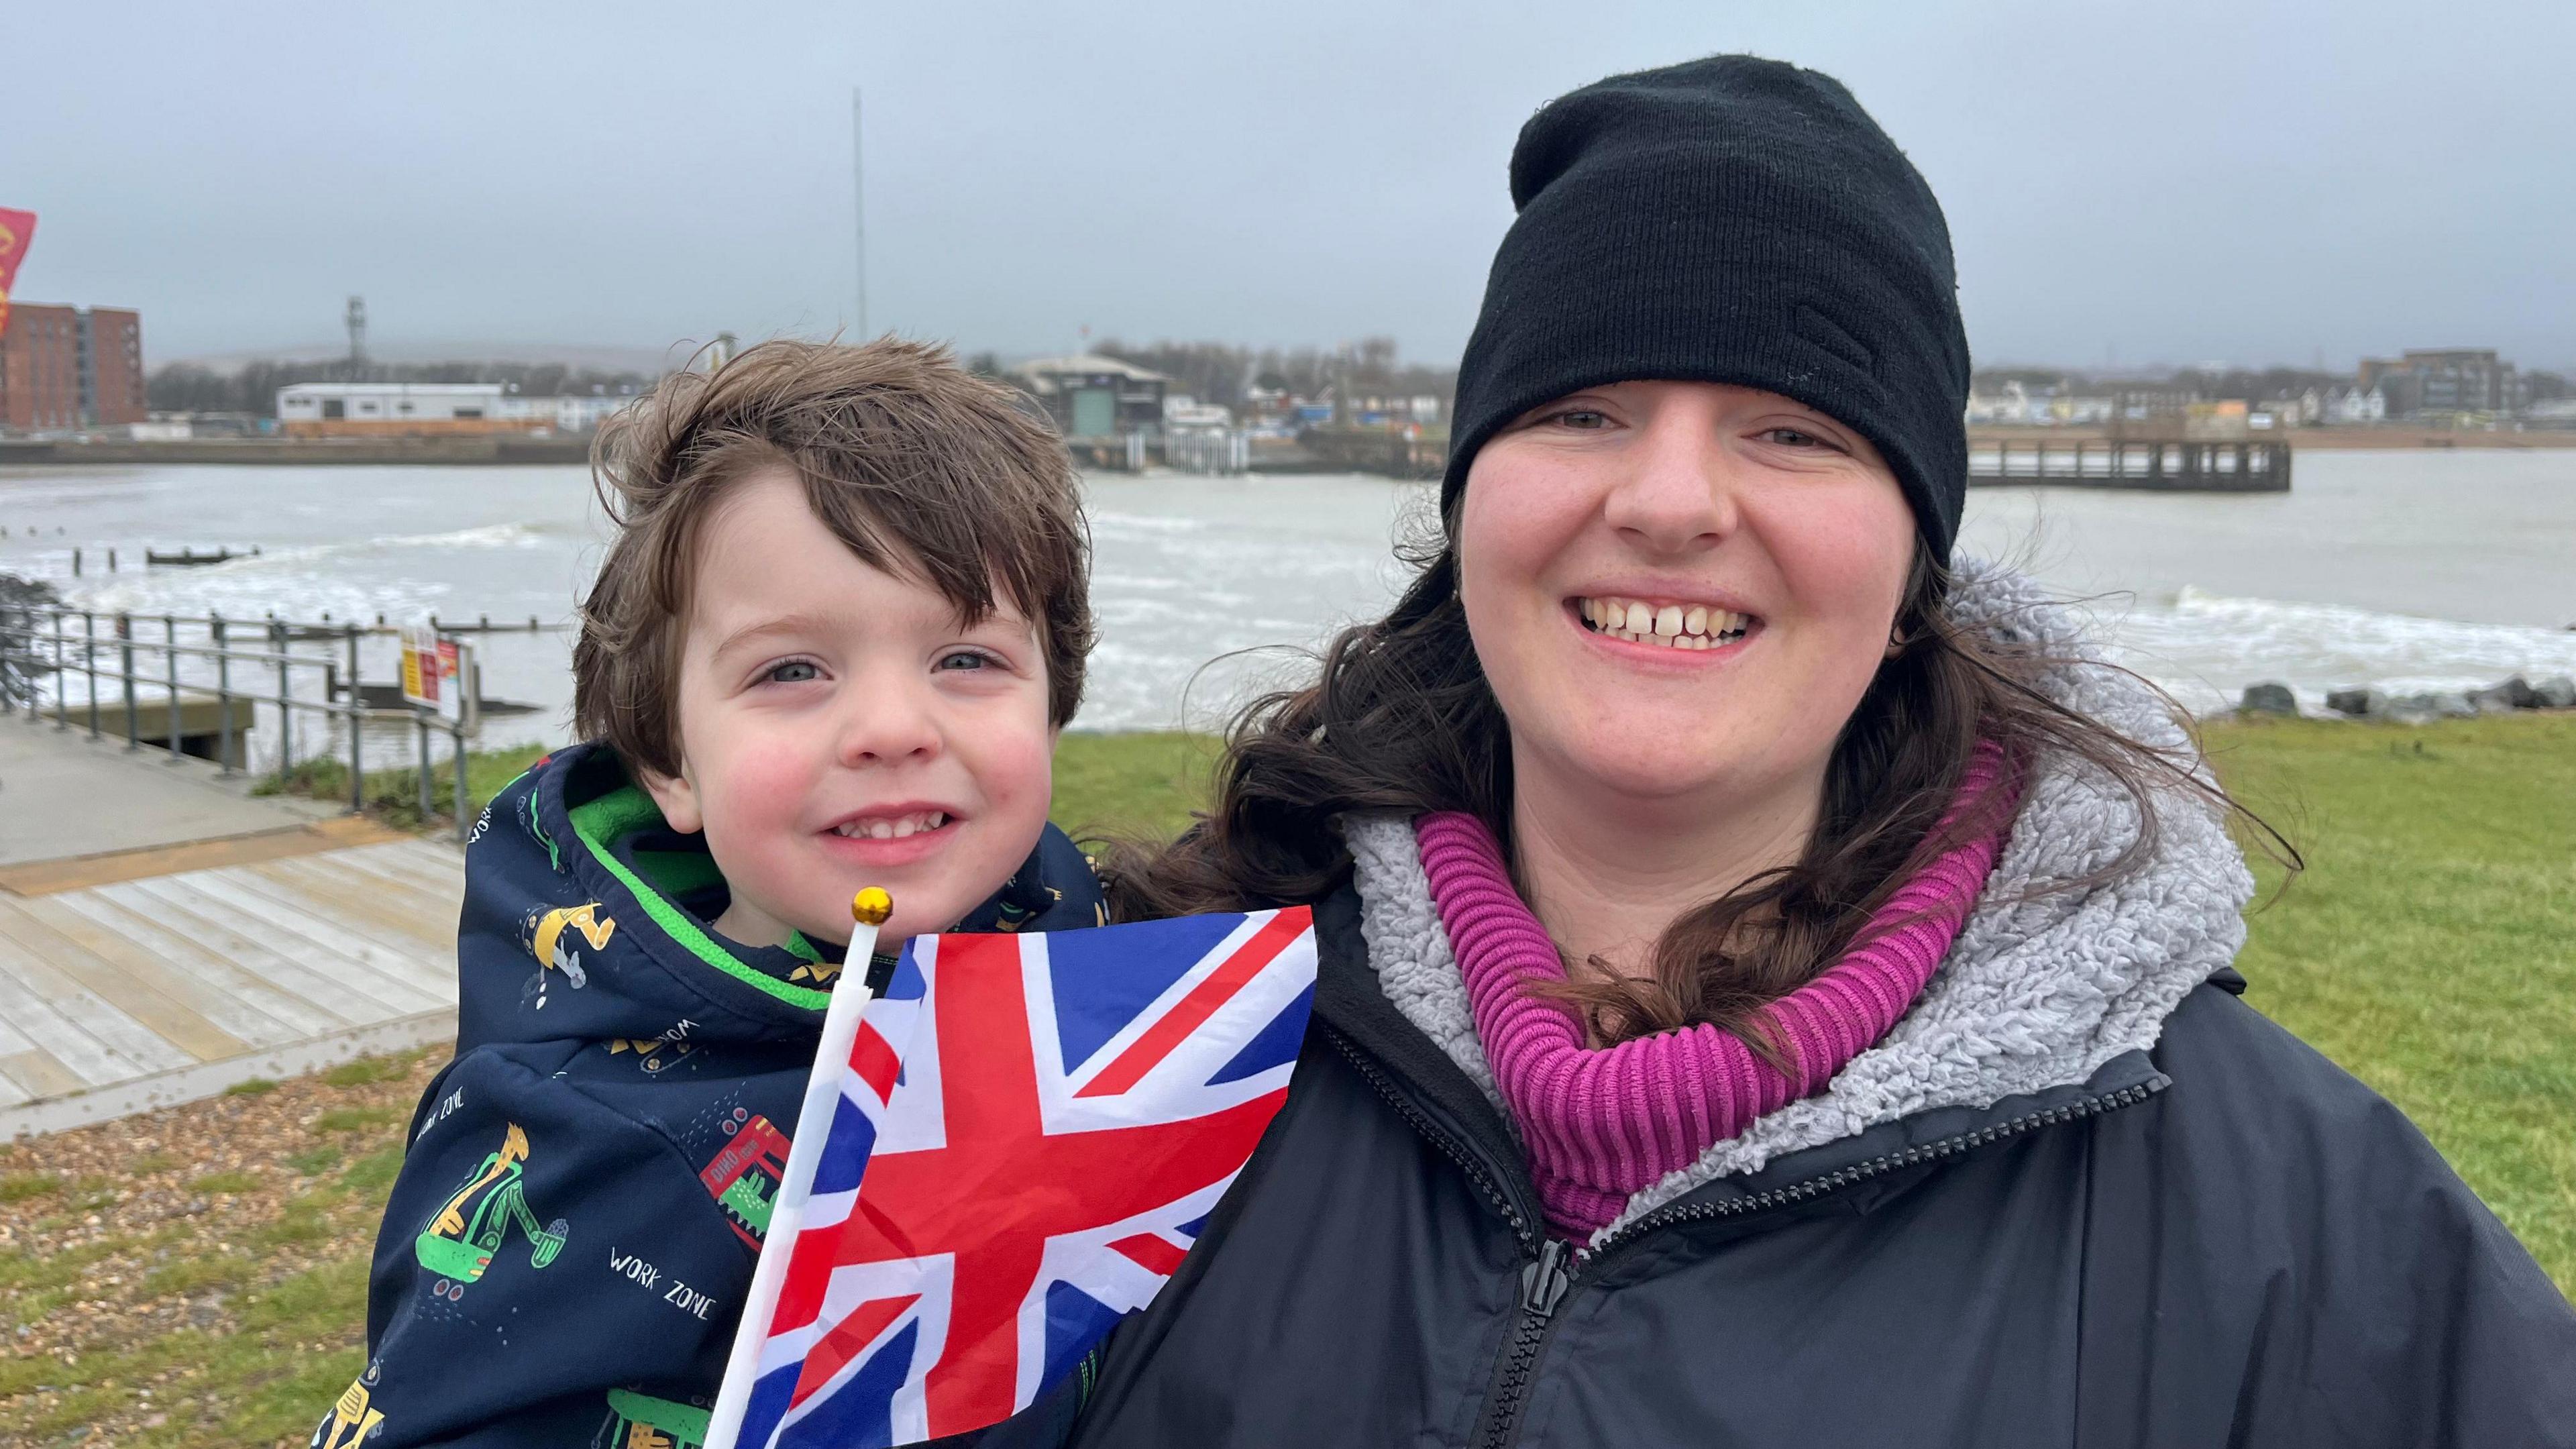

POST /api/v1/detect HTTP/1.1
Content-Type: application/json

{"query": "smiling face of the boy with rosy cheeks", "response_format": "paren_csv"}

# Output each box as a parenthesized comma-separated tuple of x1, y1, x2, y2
(644, 470, 1056, 947)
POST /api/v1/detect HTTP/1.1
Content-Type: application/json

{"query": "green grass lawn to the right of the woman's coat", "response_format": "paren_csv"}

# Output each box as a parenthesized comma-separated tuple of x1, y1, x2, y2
(2208, 714, 2576, 1294)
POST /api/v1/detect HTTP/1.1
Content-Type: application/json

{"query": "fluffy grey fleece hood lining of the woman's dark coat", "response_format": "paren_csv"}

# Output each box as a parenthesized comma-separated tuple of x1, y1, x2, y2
(1344, 559, 2254, 1245)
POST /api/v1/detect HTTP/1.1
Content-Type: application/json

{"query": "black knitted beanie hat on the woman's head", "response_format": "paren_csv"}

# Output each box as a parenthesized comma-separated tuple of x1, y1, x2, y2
(1440, 54, 1968, 562)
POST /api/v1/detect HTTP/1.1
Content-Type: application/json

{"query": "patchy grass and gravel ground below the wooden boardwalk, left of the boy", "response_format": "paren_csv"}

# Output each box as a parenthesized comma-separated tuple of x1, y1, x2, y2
(0, 1052, 445, 1446)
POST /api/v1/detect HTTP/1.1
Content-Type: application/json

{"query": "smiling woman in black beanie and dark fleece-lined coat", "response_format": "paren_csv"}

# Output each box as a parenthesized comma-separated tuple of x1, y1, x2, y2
(1007, 57, 2576, 1446)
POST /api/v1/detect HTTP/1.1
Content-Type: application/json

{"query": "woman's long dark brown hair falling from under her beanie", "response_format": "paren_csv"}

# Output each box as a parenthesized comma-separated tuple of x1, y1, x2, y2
(1108, 513, 2295, 1062)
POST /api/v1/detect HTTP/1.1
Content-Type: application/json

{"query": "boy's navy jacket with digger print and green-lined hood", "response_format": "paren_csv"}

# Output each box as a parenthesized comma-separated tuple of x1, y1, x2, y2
(314, 745, 1100, 1449)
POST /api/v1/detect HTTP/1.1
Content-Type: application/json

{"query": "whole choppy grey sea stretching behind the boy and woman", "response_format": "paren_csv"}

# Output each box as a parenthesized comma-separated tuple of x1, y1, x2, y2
(0, 449, 2576, 753)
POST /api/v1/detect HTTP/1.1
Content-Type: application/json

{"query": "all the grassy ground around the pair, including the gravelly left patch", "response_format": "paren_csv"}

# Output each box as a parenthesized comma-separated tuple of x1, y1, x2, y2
(0, 714, 2576, 1449)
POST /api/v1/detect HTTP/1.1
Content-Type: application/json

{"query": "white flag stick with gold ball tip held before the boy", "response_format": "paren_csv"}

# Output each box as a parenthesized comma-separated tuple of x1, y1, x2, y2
(706, 884, 894, 1449)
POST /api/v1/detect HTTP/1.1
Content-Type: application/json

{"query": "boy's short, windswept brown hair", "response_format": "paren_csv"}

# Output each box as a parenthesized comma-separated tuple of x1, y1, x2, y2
(572, 337, 1092, 776)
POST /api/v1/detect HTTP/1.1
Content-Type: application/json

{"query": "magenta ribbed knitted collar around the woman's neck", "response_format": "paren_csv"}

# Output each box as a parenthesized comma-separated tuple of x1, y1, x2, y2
(1414, 743, 2017, 1243)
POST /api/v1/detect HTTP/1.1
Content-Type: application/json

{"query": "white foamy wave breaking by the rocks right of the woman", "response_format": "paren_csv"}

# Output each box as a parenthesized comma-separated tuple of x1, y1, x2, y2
(2094, 588, 2576, 712)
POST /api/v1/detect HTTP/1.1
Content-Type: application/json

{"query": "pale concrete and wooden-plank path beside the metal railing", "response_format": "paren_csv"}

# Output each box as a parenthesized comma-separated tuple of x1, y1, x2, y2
(0, 719, 464, 1140)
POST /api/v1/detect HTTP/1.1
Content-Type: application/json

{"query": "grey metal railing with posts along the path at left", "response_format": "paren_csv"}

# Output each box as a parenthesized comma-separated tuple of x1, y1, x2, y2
(0, 606, 474, 841)
